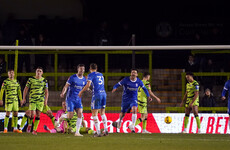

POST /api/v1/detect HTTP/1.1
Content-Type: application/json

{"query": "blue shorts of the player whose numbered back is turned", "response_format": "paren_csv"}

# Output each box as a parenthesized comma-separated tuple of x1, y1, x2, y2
(91, 93, 106, 109)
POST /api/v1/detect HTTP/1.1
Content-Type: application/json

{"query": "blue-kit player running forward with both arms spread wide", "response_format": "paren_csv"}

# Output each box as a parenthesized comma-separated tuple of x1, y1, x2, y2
(112, 69, 151, 133)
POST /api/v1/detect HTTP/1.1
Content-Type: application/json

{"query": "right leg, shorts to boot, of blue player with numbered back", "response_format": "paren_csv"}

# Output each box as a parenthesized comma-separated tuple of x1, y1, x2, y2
(100, 94, 109, 136)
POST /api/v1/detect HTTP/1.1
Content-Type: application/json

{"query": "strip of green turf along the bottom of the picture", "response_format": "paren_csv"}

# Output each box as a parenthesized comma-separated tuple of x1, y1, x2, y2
(0, 133, 230, 150)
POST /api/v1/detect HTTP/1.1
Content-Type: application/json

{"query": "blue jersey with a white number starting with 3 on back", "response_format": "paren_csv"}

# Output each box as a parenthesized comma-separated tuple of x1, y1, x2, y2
(88, 72, 105, 95)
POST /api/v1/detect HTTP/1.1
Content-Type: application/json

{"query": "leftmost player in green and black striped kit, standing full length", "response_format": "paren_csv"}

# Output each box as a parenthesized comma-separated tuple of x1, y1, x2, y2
(0, 69, 22, 133)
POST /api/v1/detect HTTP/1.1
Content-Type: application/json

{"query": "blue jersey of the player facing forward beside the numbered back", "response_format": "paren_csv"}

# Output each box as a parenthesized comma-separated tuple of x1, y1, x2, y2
(66, 74, 87, 100)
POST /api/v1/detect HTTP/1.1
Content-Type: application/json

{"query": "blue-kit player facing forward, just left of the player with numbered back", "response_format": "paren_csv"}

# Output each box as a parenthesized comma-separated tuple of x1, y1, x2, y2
(60, 64, 87, 136)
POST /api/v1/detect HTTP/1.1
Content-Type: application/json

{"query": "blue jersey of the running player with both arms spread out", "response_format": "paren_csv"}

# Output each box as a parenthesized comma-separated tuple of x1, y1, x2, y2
(113, 77, 149, 101)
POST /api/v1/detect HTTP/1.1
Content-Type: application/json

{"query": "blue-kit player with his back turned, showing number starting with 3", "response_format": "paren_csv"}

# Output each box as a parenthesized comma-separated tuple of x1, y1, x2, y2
(78, 63, 108, 137)
